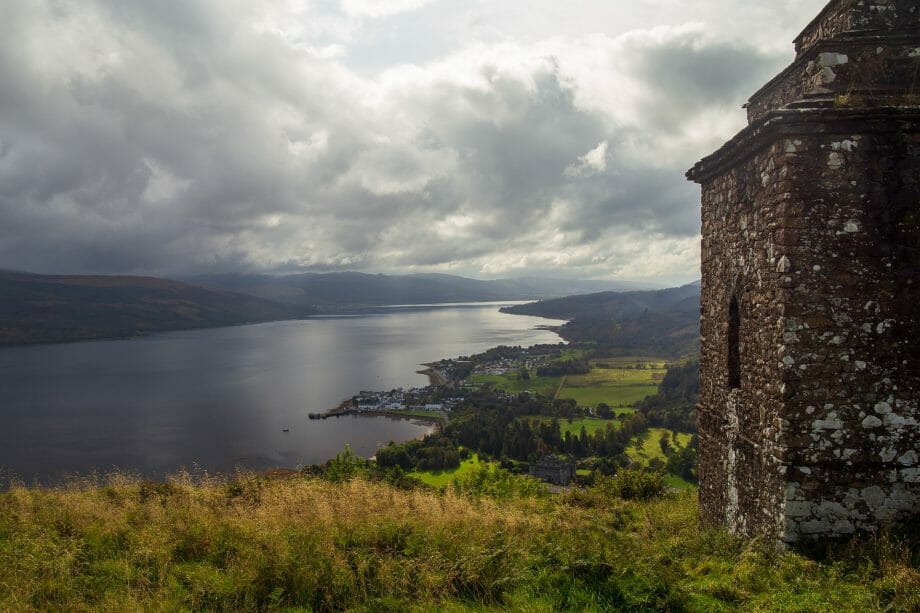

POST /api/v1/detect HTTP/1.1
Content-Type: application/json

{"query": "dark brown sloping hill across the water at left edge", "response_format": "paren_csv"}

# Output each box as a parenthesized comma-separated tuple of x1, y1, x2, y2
(0, 271, 316, 345)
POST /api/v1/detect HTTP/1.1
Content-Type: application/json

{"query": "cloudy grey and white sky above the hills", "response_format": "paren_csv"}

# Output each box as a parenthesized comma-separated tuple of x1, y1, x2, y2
(0, 0, 825, 284)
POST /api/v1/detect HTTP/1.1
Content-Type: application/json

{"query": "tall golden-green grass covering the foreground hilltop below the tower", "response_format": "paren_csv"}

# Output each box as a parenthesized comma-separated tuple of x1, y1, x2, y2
(0, 477, 920, 612)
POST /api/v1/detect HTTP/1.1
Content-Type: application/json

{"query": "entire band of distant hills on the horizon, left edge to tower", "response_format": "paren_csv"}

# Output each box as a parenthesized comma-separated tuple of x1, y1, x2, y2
(0, 271, 684, 345)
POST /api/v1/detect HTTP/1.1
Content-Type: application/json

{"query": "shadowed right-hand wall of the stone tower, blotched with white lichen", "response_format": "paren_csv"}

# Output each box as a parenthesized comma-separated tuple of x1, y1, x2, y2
(780, 111, 920, 541)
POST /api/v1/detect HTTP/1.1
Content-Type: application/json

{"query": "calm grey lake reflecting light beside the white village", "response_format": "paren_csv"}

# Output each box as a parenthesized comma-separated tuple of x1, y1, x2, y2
(0, 305, 560, 483)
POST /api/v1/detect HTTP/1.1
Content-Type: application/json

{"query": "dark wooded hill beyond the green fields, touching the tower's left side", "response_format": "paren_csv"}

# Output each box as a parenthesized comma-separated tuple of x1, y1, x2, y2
(502, 282, 700, 357)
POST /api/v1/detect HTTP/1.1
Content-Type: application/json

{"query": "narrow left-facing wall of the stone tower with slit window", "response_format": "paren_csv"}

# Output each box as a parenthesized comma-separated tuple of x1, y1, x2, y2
(699, 136, 785, 536)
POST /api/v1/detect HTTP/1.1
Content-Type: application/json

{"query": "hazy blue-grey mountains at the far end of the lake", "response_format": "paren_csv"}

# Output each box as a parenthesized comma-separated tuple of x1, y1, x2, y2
(182, 272, 648, 311)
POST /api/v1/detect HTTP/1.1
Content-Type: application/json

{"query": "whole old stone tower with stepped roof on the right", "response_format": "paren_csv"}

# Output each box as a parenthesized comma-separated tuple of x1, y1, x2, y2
(688, 0, 920, 543)
